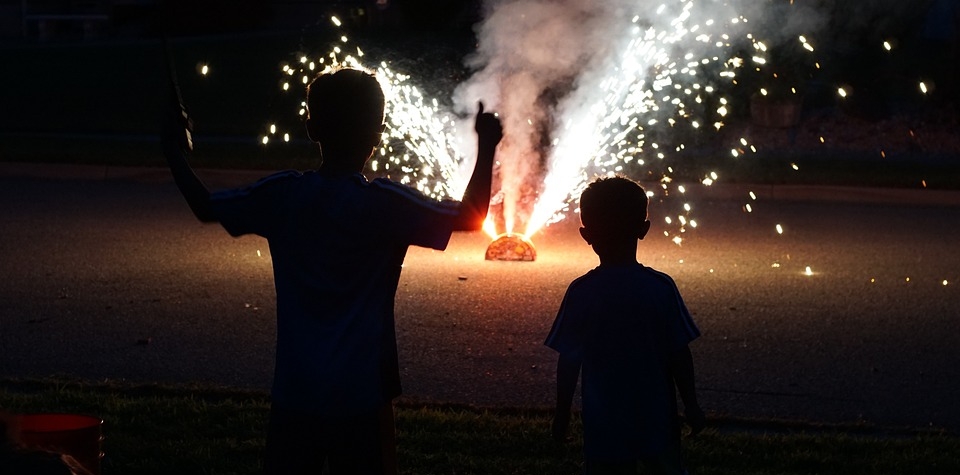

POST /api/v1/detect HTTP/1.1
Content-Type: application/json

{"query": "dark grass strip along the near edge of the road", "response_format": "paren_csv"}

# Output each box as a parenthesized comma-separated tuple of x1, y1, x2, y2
(0, 379, 960, 475)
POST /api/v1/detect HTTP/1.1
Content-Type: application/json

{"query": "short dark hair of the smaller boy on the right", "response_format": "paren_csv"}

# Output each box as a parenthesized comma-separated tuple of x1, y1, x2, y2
(580, 175, 648, 233)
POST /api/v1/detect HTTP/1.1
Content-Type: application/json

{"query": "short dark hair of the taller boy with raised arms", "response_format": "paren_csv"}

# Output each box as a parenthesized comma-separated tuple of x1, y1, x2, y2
(307, 68, 385, 136)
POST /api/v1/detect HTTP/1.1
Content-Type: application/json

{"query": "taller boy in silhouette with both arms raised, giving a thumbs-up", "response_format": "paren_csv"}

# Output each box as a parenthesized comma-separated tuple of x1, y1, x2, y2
(164, 69, 502, 475)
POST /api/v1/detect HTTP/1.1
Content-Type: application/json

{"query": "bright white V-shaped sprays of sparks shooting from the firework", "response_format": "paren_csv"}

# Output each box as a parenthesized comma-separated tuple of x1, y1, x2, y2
(262, 8, 812, 245)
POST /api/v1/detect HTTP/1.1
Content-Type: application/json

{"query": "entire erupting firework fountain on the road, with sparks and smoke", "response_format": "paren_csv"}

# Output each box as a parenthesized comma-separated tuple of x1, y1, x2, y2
(264, 0, 832, 260)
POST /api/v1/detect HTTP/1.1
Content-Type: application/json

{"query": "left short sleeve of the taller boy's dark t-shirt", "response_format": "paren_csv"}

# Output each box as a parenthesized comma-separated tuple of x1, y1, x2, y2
(210, 171, 301, 238)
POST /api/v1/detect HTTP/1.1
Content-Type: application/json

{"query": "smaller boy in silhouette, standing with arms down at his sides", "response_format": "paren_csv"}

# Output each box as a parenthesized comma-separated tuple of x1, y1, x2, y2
(546, 176, 704, 475)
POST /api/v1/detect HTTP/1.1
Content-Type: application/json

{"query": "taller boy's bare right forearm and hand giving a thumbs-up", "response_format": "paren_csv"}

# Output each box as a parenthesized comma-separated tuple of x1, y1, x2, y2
(453, 102, 503, 231)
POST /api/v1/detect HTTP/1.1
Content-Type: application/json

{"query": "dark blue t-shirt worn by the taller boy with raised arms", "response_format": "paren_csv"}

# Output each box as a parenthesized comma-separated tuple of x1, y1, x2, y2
(211, 171, 458, 416)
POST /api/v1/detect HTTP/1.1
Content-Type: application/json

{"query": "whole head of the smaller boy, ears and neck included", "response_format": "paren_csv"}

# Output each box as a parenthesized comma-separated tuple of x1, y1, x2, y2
(580, 176, 650, 254)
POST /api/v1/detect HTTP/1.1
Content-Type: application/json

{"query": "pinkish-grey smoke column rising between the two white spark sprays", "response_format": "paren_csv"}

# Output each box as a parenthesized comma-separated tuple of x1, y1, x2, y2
(454, 0, 617, 231)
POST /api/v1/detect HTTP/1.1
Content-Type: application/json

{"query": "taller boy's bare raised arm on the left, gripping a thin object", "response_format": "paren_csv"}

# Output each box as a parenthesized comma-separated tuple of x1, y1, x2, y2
(161, 78, 217, 223)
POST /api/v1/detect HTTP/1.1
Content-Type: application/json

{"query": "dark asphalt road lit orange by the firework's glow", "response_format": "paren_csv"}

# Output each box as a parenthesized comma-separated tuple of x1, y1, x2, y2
(0, 166, 960, 430)
